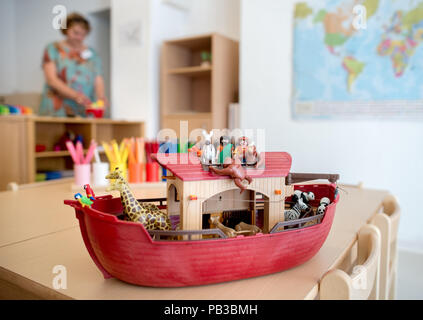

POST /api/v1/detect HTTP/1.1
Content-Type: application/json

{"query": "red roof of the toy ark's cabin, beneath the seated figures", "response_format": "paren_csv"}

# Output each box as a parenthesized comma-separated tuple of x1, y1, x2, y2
(152, 152, 292, 181)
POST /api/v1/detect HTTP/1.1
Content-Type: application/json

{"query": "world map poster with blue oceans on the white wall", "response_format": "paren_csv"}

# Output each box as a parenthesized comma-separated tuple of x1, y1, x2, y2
(292, 0, 423, 119)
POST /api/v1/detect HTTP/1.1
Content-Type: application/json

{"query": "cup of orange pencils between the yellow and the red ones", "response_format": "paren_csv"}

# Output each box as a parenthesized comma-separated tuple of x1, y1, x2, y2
(126, 138, 144, 183)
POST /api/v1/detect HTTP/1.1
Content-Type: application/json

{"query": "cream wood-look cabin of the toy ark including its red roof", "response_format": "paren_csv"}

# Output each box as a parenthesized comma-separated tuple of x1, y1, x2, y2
(154, 152, 294, 233)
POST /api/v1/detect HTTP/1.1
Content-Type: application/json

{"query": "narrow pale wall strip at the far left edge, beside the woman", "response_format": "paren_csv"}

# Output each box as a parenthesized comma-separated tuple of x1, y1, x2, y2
(0, 0, 16, 94)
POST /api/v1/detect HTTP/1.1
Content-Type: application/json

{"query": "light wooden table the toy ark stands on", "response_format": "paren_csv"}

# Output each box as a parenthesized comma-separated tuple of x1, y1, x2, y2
(0, 181, 389, 300)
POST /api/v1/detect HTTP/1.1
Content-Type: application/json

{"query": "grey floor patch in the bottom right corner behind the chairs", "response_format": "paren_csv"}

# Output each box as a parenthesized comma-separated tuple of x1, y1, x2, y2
(397, 250, 423, 300)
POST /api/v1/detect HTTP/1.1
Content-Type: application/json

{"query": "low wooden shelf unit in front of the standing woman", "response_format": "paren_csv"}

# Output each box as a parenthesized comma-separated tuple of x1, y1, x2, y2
(0, 116, 144, 190)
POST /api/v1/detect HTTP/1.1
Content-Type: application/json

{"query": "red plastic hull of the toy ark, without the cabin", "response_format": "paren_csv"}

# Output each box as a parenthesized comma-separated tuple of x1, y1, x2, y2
(65, 185, 339, 287)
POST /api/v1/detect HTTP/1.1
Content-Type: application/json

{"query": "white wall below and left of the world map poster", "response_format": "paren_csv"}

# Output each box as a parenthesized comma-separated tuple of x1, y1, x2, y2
(240, 0, 423, 250)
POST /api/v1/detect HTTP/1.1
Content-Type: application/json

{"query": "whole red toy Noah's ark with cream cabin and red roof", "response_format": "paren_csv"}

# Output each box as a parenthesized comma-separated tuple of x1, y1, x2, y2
(65, 152, 339, 287)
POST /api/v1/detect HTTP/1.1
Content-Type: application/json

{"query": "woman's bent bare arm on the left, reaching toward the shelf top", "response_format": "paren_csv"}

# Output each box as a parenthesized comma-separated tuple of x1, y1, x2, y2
(43, 61, 91, 107)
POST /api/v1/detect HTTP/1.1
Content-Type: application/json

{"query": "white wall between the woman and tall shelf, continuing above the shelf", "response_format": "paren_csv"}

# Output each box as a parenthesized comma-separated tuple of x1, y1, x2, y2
(112, 0, 239, 137)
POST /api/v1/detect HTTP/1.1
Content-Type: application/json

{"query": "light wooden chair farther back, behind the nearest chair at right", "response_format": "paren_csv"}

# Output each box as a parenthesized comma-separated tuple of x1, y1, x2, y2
(371, 195, 401, 300)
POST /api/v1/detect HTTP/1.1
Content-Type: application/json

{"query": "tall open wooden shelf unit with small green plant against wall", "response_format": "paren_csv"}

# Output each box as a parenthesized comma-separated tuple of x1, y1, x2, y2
(161, 33, 239, 136)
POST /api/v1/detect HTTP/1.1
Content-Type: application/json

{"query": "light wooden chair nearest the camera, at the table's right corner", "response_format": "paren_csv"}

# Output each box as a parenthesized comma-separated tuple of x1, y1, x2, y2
(319, 224, 381, 300)
